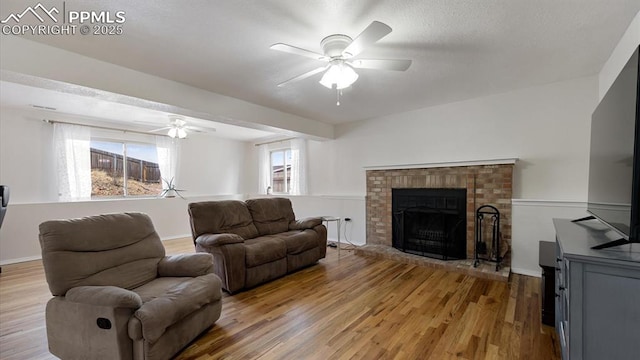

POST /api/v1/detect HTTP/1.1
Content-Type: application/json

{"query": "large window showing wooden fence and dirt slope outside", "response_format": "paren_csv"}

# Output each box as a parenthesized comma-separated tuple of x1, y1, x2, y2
(90, 139, 162, 198)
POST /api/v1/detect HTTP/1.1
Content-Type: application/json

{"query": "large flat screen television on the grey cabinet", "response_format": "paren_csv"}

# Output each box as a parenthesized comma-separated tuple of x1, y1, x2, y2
(587, 43, 640, 249)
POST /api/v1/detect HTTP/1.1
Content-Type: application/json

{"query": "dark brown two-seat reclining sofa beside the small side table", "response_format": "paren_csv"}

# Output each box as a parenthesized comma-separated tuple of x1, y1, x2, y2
(189, 198, 327, 293)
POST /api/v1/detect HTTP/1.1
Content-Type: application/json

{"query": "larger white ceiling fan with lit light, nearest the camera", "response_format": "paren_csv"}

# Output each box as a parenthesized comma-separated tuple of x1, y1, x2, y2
(271, 21, 411, 105)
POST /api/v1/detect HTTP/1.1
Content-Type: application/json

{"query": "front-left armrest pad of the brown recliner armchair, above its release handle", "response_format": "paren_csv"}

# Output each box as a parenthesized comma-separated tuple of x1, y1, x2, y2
(65, 286, 142, 309)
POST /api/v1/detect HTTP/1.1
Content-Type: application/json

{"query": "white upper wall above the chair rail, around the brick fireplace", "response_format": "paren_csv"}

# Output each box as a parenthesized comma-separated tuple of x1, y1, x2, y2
(310, 77, 597, 200)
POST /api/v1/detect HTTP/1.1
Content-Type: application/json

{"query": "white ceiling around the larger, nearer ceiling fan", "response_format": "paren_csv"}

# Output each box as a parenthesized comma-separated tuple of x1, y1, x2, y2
(0, 0, 640, 123)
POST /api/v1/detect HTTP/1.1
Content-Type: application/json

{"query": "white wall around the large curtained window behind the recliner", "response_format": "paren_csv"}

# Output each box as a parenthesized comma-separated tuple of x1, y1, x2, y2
(0, 108, 247, 264)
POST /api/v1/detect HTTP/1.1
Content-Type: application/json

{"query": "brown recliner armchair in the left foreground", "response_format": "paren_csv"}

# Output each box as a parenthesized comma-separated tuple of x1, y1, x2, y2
(40, 213, 222, 359)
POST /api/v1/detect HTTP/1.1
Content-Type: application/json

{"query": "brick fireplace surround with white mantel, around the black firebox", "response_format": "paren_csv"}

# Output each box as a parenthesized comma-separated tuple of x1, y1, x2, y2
(366, 159, 515, 265)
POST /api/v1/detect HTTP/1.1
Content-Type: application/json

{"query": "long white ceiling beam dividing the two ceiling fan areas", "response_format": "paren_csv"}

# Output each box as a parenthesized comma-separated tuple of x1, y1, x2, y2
(0, 36, 334, 140)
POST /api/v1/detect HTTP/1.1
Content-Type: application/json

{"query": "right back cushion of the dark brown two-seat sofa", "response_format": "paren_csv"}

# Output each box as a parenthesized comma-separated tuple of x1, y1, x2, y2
(246, 198, 295, 236)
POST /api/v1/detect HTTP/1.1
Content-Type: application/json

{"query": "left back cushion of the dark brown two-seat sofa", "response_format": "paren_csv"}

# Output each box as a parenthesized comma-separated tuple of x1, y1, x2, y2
(189, 200, 258, 240)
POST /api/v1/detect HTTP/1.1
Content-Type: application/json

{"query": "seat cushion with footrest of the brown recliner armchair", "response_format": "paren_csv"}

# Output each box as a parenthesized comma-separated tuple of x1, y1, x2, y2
(133, 274, 222, 343)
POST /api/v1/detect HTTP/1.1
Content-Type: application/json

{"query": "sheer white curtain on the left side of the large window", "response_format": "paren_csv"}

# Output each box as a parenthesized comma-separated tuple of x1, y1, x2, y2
(53, 123, 91, 201)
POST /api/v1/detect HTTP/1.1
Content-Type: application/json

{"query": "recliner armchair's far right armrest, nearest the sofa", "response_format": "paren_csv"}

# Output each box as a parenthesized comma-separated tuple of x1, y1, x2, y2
(158, 253, 213, 277)
